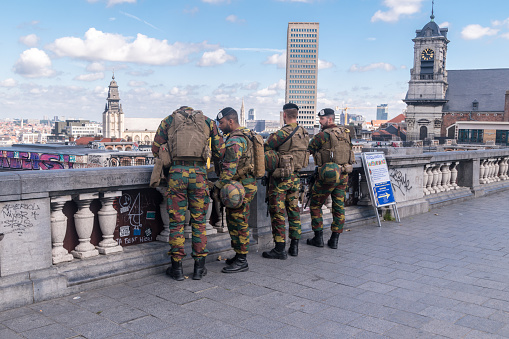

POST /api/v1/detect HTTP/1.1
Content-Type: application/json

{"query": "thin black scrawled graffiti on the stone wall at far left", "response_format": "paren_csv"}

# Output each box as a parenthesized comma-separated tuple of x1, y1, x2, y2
(0, 203, 41, 236)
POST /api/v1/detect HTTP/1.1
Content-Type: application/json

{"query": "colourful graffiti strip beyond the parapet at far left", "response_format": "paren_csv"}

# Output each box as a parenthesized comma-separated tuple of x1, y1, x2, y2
(0, 151, 87, 170)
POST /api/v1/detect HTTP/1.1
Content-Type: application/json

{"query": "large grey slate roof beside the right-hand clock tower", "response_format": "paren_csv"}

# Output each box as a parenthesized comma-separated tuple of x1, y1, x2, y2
(443, 68, 509, 112)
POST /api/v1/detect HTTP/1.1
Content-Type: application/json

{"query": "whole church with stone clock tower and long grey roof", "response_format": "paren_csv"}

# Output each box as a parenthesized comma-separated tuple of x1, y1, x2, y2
(403, 12, 509, 144)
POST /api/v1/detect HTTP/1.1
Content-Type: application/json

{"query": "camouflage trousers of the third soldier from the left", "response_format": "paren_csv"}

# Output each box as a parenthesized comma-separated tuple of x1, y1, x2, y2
(269, 173, 301, 242)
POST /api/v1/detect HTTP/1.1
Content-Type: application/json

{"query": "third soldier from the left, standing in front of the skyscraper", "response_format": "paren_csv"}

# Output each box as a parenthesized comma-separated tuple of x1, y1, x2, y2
(262, 103, 309, 260)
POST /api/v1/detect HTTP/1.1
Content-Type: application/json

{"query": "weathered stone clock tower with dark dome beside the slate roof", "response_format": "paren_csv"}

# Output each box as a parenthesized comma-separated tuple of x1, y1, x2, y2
(403, 11, 449, 140)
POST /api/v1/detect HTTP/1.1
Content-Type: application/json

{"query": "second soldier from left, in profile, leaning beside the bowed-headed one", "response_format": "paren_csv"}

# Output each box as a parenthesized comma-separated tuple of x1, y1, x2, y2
(214, 107, 257, 273)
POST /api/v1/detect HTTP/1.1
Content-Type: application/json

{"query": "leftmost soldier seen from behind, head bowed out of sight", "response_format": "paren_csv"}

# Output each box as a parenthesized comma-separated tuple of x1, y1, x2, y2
(152, 106, 224, 280)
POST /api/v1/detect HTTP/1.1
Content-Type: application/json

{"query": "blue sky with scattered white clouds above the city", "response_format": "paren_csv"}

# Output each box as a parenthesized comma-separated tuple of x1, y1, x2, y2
(0, 0, 509, 121)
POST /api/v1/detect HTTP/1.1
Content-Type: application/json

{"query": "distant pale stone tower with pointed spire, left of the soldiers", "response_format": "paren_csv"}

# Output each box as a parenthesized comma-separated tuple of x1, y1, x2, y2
(103, 74, 124, 138)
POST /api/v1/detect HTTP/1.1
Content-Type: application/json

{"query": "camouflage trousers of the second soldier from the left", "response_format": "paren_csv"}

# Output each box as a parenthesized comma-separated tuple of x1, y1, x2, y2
(226, 178, 257, 254)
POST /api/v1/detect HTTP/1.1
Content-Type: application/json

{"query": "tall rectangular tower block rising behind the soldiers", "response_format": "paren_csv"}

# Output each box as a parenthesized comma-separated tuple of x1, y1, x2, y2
(285, 22, 319, 129)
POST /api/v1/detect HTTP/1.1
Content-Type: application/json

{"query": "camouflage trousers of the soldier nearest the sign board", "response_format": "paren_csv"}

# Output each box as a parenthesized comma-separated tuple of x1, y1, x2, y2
(309, 173, 348, 233)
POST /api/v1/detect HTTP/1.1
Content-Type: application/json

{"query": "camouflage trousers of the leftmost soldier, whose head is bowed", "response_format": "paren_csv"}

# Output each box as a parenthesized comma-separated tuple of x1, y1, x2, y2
(168, 166, 210, 261)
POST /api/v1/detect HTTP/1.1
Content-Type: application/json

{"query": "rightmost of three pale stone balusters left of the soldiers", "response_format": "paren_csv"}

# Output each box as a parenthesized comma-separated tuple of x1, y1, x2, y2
(96, 191, 124, 254)
